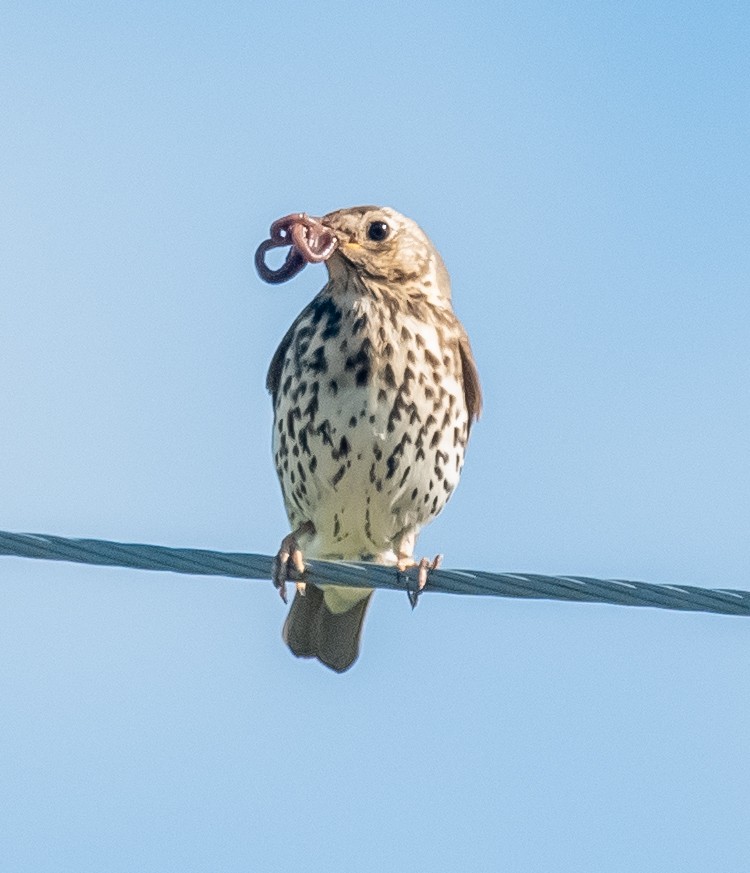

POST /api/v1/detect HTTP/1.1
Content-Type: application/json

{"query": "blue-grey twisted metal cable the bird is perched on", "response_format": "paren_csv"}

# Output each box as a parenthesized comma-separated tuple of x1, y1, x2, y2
(0, 531, 750, 615)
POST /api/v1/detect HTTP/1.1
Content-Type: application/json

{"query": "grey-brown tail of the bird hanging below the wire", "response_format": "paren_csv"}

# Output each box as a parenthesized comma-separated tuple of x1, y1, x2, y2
(281, 583, 373, 673)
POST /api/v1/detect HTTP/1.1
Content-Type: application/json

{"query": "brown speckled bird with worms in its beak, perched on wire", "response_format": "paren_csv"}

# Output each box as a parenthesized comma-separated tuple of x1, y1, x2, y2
(256, 206, 482, 673)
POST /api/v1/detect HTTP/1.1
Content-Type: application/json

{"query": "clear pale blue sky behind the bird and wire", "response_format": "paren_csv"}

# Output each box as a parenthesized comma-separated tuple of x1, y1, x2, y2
(0, 0, 750, 873)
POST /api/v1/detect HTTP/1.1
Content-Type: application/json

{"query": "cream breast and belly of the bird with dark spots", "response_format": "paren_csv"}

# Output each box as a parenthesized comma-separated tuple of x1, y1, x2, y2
(268, 283, 470, 559)
